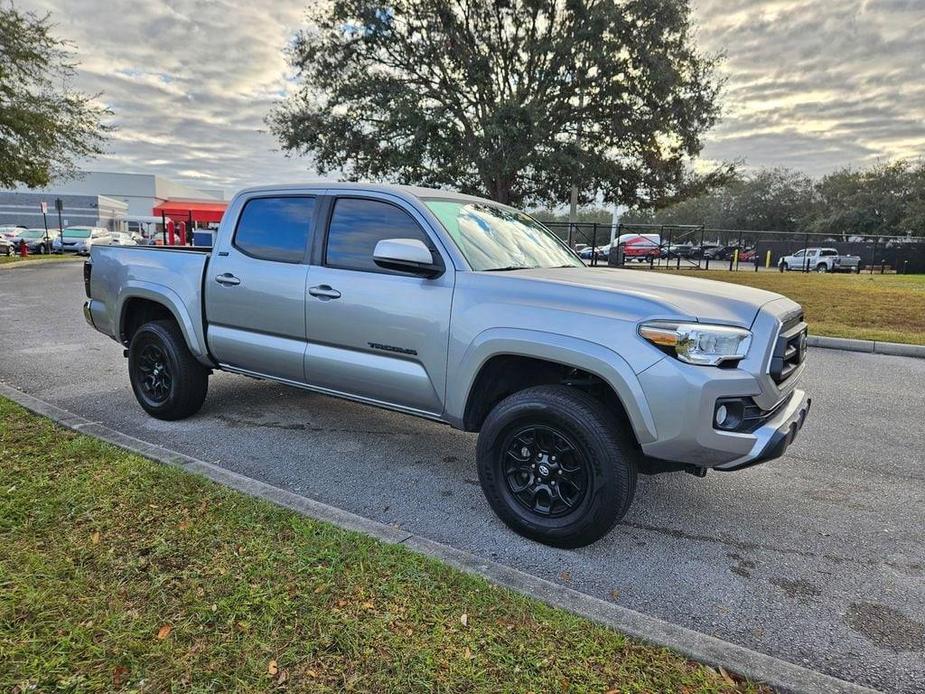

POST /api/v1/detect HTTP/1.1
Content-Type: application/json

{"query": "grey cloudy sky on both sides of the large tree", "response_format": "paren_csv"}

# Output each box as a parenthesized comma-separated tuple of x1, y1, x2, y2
(16, 0, 925, 192)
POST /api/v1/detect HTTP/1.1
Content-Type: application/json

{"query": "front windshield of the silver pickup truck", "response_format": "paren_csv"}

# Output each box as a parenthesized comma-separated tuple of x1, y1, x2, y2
(424, 200, 584, 271)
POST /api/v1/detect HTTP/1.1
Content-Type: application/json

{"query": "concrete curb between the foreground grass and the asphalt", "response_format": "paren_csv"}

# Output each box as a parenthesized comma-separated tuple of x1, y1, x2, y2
(0, 383, 876, 694)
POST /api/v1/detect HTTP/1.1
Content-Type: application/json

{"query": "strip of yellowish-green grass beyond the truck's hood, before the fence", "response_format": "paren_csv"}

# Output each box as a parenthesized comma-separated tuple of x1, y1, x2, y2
(656, 270, 925, 345)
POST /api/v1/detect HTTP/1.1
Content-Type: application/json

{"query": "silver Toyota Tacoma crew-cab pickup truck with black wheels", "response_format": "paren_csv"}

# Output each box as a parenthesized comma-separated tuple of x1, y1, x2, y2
(84, 184, 810, 547)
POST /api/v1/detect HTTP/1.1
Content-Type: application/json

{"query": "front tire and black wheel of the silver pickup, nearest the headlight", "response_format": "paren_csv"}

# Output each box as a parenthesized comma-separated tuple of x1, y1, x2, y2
(477, 385, 641, 548)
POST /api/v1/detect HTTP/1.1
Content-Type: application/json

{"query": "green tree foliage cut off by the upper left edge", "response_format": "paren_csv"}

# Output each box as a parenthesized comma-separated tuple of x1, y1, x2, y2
(0, 5, 110, 188)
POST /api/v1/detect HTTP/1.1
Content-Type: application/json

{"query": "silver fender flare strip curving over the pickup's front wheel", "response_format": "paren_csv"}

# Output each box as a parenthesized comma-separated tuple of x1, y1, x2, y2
(446, 328, 657, 444)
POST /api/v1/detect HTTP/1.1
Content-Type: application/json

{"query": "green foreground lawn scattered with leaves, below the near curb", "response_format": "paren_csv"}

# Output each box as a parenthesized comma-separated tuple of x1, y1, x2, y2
(0, 399, 761, 692)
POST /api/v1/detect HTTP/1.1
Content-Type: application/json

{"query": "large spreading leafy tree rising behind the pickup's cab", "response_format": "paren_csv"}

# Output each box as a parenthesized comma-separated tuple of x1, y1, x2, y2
(268, 0, 725, 205)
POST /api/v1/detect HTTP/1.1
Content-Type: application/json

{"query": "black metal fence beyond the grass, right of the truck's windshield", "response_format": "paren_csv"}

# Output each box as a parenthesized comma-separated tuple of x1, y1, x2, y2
(546, 222, 925, 274)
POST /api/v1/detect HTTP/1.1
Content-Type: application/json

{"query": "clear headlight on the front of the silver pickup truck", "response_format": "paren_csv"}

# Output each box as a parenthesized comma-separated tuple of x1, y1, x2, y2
(639, 321, 752, 366)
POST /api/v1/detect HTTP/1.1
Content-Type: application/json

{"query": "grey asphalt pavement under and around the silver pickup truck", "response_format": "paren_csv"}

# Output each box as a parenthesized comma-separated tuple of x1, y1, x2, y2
(0, 263, 925, 692)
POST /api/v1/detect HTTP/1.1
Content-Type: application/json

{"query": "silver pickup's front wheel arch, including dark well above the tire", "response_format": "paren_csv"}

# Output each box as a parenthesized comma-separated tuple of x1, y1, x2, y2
(446, 329, 657, 443)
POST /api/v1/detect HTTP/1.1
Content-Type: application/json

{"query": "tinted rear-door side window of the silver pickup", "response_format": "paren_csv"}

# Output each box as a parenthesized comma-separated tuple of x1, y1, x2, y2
(234, 197, 315, 263)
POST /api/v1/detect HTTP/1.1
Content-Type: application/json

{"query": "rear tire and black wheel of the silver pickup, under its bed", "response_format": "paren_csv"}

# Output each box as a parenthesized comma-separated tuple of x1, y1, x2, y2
(128, 320, 209, 421)
